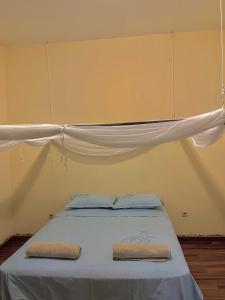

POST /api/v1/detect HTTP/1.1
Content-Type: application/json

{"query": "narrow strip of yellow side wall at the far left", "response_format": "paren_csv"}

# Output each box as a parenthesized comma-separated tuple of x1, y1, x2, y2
(0, 46, 13, 244)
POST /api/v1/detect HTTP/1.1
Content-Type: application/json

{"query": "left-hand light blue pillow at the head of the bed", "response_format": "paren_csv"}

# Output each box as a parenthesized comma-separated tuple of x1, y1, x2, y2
(66, 194, 116, 209)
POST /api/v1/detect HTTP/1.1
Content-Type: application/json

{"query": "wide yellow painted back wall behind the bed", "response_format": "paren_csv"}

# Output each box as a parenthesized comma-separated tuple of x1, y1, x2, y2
(3, 31, 225, 234)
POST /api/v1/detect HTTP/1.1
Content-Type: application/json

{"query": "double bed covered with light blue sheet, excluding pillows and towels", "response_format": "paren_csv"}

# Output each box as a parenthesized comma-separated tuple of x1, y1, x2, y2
(0, 207, 203, 300)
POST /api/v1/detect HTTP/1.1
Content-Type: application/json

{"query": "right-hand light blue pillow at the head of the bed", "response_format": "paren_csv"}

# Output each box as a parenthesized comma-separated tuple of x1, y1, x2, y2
(113, 194, 161, 209)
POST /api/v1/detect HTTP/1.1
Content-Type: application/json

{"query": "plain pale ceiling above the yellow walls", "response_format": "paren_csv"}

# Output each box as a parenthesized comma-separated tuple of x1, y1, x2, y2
(0, 0, 225, 44)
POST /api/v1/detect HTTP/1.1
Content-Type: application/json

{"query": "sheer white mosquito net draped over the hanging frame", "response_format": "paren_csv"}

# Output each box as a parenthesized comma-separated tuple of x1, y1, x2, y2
(0, 108, 225, 157)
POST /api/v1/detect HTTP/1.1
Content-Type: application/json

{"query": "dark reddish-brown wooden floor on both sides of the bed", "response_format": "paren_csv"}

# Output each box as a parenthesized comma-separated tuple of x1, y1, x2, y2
(0, 237, 225, 300)
